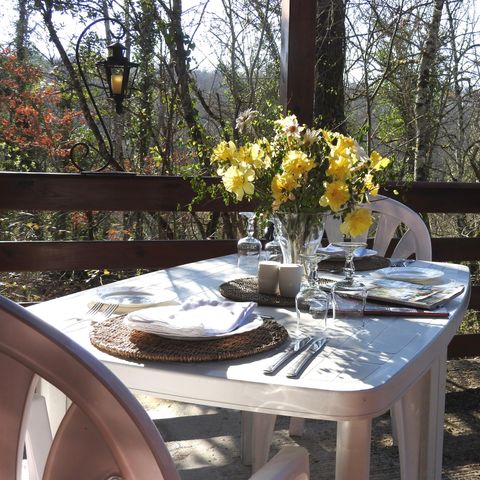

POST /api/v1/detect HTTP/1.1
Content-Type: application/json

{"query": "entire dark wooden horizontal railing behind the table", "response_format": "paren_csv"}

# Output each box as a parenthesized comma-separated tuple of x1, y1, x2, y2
(0, 172, 480, 355)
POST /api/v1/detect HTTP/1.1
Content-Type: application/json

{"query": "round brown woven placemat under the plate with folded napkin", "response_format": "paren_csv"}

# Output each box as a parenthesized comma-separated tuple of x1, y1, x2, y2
(90, 317, 288, 362)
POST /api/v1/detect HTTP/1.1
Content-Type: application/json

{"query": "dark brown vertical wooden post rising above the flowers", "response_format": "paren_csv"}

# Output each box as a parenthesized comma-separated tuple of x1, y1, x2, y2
(280, 0, 316, 125)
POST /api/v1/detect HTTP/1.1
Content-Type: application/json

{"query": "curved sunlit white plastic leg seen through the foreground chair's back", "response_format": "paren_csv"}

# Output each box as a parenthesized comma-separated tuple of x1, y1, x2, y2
(25, 394, 52, 480)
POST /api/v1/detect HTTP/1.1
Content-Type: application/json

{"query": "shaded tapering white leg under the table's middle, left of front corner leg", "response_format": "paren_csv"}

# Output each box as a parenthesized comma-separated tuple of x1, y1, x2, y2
(241, 412, 277, 472)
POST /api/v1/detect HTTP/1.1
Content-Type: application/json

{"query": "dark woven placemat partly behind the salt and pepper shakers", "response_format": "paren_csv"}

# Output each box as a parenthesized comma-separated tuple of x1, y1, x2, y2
(218, 277, 295, 308)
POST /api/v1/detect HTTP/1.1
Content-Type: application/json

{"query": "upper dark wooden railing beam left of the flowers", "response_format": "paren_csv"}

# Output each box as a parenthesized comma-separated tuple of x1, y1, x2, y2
(0, 172, 249, 212)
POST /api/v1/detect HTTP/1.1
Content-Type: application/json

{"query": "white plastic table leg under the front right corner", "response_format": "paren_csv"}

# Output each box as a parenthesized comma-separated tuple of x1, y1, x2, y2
(335, 418, 372, 480)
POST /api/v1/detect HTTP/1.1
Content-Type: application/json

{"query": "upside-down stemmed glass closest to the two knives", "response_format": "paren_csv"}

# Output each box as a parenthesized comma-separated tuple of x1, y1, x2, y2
(295, 254, 331, 335)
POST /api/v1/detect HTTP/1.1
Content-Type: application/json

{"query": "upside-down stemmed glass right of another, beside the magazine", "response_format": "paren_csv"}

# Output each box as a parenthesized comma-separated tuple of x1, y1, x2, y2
(332, 242, 367, 328)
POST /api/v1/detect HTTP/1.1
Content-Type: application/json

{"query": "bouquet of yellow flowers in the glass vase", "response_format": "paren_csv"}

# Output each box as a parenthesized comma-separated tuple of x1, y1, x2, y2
(211, 110, 390, 238)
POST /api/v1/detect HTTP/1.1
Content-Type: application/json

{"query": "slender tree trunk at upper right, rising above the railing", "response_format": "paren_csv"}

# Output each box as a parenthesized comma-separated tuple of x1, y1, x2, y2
(415, 0, 444, 181)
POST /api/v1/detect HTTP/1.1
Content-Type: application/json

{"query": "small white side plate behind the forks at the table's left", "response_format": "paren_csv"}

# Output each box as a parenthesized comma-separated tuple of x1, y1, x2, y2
(93, 286, 178, 312)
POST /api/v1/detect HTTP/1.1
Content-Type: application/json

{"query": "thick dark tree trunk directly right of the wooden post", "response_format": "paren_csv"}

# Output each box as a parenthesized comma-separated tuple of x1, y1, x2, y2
(314, 0, 346, 132)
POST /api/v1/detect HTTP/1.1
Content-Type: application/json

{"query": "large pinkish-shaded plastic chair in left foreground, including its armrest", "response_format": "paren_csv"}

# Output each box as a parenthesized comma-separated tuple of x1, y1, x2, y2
(0, 297, 309, 480)
